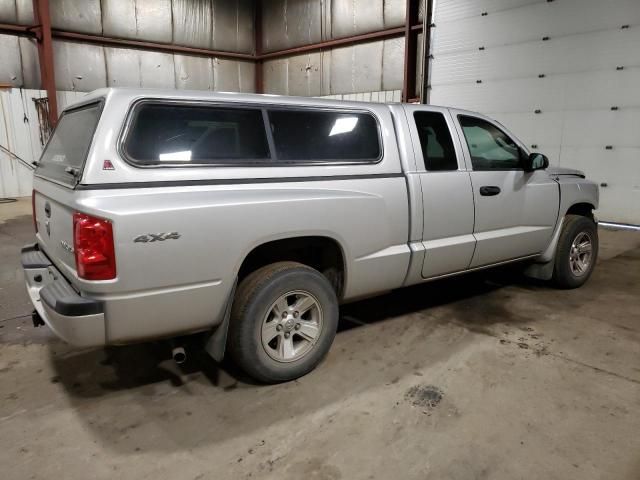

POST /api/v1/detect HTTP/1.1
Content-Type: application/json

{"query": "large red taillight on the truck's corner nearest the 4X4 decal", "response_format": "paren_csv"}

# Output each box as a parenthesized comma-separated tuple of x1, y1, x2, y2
(73, 212, 116, 280)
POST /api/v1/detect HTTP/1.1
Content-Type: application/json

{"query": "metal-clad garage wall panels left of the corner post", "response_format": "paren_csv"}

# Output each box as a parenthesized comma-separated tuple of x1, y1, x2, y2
(0, 0, 255, 197)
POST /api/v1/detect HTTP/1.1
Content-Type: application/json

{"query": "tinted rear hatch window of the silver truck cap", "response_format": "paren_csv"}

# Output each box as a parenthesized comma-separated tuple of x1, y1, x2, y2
(36, 102, 102, 186)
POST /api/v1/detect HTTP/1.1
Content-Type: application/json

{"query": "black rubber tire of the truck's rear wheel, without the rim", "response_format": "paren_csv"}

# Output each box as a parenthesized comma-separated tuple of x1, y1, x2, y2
(227, 262, 338, 383)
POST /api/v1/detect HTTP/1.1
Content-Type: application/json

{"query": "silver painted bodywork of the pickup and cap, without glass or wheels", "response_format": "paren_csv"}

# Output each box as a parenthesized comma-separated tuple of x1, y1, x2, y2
(22, 89, 598, 346)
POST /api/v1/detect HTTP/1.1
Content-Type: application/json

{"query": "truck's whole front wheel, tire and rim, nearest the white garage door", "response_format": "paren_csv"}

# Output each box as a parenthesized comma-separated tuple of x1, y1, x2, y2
(553, 215, 598, 288)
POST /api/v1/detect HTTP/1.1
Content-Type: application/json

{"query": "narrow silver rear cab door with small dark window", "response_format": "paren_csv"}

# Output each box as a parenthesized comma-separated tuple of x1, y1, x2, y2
(405, 105, 476, 278)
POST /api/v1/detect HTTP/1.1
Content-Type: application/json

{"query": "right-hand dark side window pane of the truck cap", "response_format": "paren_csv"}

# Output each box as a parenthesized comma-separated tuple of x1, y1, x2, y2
(269, 110, 380, 162)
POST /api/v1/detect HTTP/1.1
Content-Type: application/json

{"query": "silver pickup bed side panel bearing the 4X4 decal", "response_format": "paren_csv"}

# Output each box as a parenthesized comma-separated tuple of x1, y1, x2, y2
(76, 177, 409, 342)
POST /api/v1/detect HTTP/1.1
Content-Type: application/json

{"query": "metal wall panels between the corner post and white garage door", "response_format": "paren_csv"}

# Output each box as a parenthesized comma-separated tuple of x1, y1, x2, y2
(262, 0, 424, 96)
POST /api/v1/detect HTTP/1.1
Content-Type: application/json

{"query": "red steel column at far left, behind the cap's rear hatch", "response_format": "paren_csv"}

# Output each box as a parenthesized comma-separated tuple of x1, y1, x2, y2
(33, 0, 58, 126)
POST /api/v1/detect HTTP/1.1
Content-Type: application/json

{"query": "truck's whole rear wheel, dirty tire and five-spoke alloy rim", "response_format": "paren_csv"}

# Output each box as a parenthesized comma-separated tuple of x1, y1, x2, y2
(228, 262, 338, 383)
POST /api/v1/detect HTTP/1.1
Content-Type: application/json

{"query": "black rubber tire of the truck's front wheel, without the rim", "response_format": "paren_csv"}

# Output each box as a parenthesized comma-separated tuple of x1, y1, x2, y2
(552, 215, 598, 289)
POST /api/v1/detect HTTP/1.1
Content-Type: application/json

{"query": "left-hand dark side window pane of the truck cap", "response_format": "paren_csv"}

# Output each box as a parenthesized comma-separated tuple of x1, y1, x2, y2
(124, 103, 269, 165)
